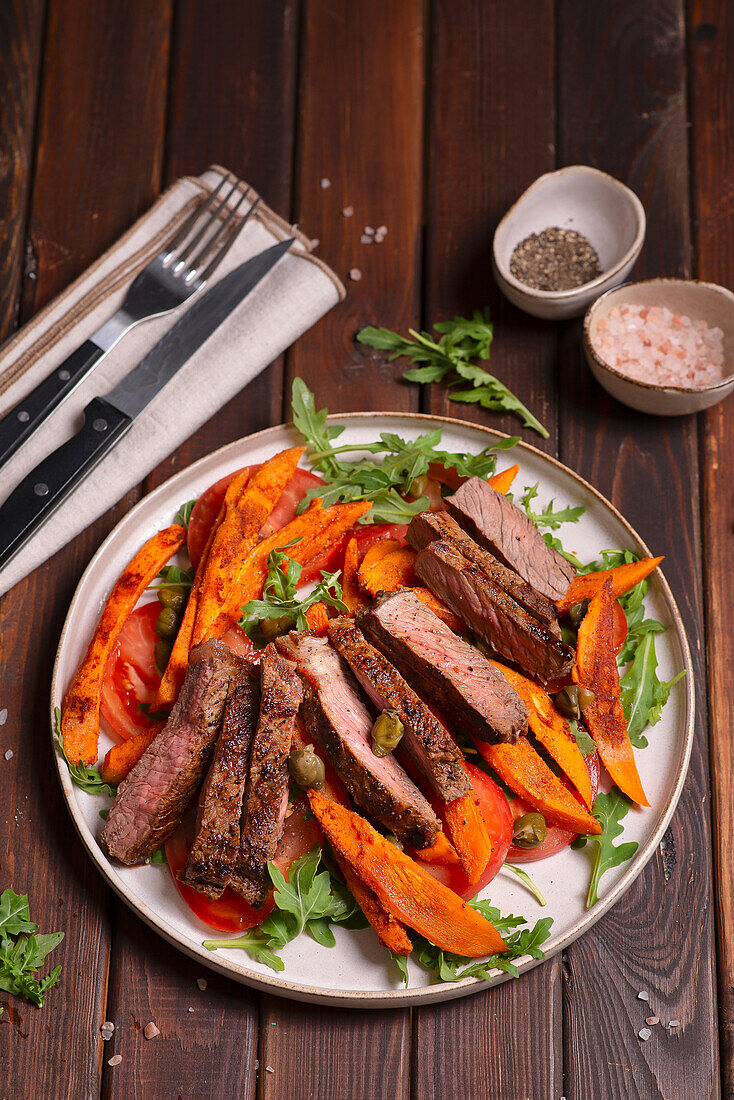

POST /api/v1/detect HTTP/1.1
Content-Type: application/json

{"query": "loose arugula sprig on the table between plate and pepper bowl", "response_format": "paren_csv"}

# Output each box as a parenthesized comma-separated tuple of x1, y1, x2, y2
(357, 308, 548, 439)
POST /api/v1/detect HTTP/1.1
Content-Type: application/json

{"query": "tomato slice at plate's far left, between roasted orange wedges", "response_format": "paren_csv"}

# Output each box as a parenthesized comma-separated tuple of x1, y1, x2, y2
(101, 600, 161, 741)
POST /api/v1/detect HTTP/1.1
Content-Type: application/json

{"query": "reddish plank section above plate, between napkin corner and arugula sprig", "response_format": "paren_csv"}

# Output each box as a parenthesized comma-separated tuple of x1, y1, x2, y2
(287, 0, 424, 413)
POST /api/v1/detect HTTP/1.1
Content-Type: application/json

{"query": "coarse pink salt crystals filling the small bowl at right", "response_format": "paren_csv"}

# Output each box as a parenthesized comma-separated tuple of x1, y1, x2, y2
(593, 306, 724, 389)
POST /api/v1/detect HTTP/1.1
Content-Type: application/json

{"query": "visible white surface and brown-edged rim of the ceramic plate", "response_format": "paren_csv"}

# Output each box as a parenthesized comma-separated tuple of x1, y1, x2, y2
(52, 414, 693, 1008)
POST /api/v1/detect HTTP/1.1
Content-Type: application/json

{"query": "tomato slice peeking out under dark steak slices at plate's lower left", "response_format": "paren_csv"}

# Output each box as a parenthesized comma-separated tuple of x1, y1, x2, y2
(166, 795, 321, 932)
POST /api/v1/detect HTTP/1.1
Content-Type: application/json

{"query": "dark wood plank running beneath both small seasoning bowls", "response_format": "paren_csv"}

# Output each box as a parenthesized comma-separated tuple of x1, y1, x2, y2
(558, 0, 719, 1100)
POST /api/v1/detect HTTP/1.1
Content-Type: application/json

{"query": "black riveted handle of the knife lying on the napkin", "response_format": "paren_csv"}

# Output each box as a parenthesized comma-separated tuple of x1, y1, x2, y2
(0, 397, 132, 569)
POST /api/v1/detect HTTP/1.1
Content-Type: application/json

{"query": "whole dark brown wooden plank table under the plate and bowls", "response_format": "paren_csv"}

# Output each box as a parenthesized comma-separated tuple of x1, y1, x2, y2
(0, 0, 734, 1100)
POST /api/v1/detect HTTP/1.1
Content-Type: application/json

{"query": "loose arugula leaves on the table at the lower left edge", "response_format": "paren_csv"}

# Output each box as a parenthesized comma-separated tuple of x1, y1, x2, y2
(0, 888, 64, 1009)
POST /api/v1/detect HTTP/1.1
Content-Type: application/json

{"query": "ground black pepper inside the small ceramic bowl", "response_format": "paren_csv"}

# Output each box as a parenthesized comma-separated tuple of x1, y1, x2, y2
(510, 226, 602, 290)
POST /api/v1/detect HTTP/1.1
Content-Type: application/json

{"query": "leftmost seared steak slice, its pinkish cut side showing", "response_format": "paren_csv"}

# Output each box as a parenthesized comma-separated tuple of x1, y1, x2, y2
(100, 640, 234, 865)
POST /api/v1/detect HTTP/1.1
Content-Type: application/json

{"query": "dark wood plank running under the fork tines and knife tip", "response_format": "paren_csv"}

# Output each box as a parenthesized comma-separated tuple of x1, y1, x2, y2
(106, 0, 297, 1098)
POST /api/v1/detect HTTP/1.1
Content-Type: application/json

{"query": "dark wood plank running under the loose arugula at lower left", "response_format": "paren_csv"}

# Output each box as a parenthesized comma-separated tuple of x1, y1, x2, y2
(0, 0, 168, 1097)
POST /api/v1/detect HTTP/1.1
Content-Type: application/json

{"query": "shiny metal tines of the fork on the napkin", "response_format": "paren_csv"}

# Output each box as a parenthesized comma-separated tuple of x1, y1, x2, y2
(163, 174, 260, 284)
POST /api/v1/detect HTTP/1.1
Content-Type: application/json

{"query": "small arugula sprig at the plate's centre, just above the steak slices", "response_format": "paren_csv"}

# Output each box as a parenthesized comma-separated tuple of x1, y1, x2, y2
(240, 543, 349, 646)
